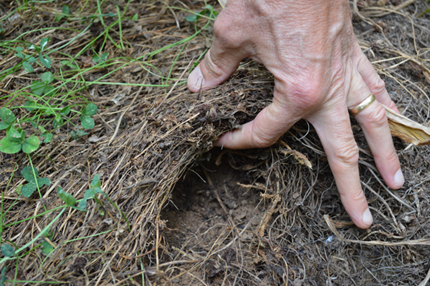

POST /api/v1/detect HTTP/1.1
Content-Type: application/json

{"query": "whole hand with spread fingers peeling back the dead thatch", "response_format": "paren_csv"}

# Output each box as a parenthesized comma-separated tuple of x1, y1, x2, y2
(188, 0, 404, 228)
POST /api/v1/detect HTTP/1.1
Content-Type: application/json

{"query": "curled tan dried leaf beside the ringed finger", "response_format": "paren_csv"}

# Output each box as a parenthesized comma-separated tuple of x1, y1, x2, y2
(382, 105, 430, 145)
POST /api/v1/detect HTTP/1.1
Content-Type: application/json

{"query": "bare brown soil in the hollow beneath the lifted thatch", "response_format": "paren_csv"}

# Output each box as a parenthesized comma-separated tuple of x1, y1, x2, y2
(161, 152, 264, 285)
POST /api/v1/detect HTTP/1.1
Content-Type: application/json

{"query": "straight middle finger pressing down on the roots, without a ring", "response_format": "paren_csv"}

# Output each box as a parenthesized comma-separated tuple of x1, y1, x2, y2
(310, 106, 373, 228)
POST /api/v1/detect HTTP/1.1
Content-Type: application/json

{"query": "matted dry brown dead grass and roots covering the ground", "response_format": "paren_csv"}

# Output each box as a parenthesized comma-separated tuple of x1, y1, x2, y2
(0, 0, 430, 285)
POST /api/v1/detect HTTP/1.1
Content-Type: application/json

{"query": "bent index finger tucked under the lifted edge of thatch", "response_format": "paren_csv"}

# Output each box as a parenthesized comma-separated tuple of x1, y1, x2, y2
(215, 99, 297, 149)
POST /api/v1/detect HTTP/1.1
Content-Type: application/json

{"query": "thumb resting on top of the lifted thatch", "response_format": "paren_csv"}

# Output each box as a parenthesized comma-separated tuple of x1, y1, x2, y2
(188, 41, 246, 92)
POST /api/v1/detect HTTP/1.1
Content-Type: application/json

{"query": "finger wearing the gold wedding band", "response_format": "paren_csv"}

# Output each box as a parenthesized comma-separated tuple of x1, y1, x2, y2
(348, 68, 404, 189)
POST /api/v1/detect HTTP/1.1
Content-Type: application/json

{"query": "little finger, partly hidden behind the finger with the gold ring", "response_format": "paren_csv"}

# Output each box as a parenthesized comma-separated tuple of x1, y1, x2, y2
(354, 43, 400, 113)
